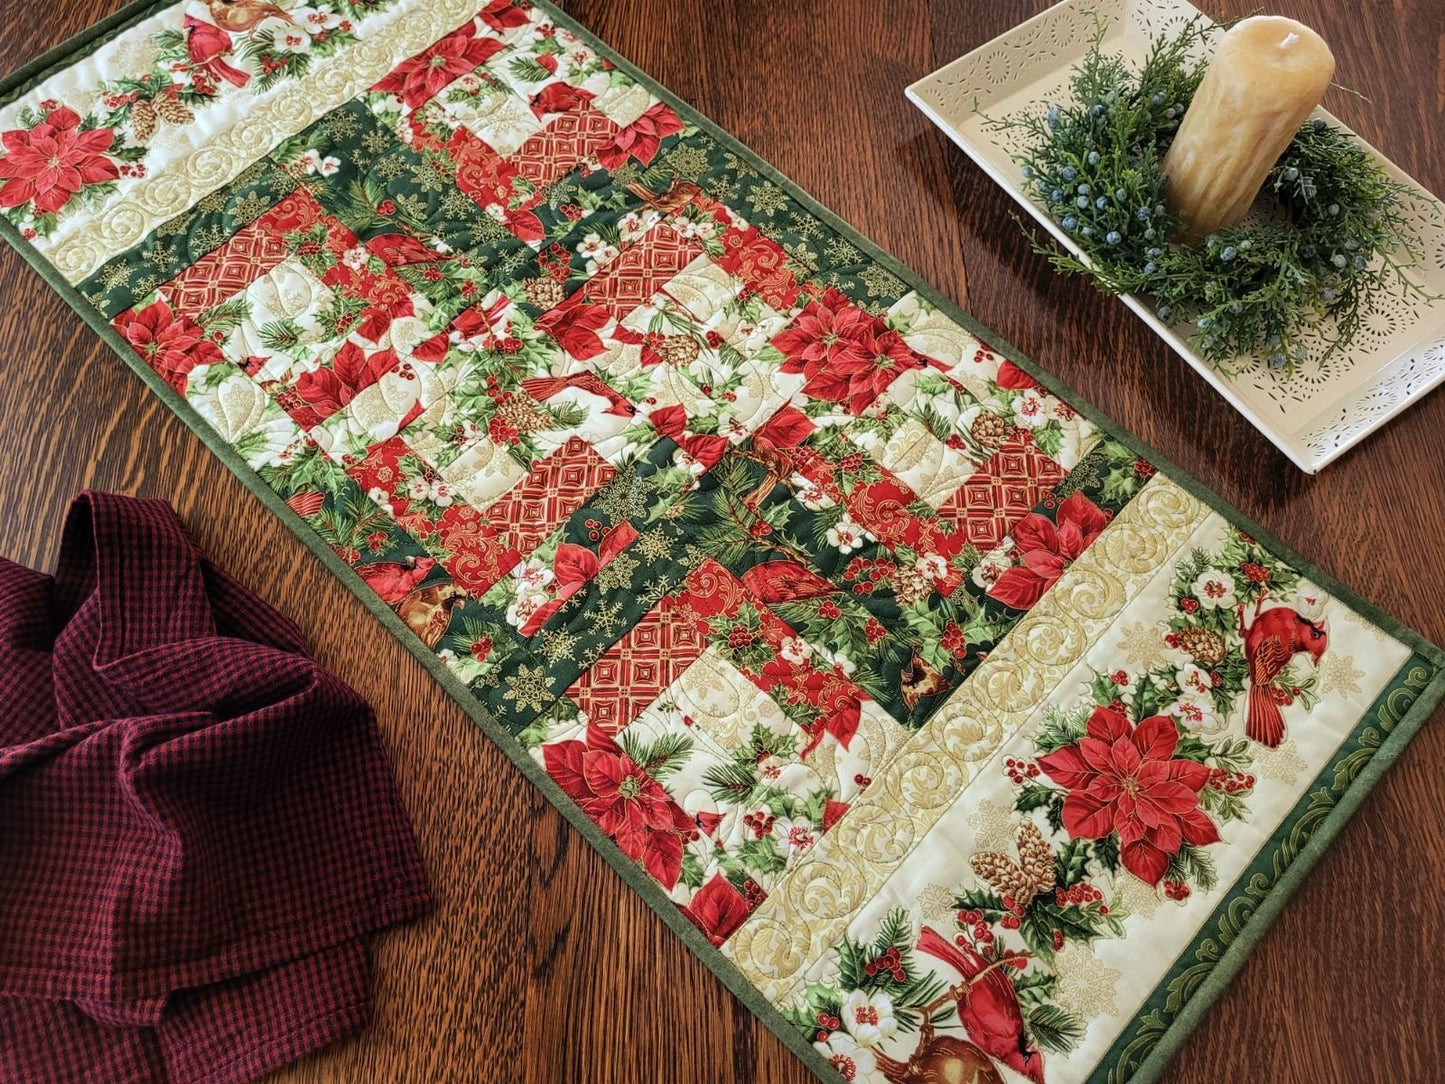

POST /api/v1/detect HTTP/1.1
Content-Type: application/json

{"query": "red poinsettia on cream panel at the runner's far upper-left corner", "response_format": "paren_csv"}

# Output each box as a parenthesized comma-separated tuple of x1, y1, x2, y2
(0, 107, 120, 214)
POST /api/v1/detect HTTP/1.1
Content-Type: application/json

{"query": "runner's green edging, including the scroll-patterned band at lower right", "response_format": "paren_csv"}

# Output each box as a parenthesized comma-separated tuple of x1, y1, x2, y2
(0, 0, 1445, 1084)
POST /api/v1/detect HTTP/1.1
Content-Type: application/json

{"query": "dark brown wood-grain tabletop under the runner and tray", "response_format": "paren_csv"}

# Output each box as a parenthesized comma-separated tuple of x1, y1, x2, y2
(0, 0, 1445, 1084)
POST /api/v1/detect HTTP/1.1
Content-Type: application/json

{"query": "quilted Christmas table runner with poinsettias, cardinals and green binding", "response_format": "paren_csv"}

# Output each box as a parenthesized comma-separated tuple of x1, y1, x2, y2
(0, 0, 1445, 1084)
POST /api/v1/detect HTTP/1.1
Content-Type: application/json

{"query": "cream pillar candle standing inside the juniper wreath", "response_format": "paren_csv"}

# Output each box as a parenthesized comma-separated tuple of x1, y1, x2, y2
(1163, 16, 1335, 240)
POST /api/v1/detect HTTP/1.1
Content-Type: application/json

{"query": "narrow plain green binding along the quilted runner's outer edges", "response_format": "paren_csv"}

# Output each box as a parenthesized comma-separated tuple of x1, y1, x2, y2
(0, 0, 1445, 1084)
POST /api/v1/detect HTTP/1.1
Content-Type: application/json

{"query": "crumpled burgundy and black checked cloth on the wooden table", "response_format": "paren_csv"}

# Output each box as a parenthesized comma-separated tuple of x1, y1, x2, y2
(0, 493, 429, 1084)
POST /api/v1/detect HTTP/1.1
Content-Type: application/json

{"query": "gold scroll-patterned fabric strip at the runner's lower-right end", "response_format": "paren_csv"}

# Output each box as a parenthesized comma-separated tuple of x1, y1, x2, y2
(723, 476, 1208, 1000)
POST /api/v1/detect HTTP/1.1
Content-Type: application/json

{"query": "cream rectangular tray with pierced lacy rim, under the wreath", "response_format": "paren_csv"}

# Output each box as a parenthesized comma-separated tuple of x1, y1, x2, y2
(907, 0, 1445, 474)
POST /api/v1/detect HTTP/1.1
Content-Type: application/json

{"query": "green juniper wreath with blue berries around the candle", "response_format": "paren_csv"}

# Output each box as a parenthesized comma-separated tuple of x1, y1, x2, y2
(991, 19, 1420, 370)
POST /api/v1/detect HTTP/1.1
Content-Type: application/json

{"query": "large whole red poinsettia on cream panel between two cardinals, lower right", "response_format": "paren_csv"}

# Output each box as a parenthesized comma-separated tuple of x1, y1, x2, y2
(1039, 707, 1220, 885)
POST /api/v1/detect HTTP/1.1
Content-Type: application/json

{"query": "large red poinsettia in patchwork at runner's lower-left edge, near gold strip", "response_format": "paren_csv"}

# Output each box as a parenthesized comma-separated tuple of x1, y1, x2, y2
(542, 728, 698, 890)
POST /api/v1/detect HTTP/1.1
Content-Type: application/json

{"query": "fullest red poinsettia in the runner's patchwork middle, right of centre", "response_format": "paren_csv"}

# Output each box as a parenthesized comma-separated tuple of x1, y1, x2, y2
(773, 286, 926, 415)
